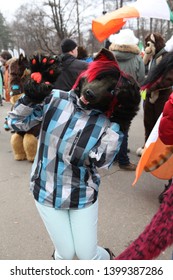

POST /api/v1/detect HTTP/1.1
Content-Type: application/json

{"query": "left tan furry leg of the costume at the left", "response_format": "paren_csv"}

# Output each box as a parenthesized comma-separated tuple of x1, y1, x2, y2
(11, 133, 26, 160)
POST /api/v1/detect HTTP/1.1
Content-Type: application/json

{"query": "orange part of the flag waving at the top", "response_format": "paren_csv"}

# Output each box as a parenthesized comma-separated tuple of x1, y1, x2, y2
(92, 6, 140, 42)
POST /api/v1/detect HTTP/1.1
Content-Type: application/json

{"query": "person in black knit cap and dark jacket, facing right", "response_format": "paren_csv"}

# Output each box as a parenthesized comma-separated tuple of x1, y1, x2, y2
(54, 39, 88, 91)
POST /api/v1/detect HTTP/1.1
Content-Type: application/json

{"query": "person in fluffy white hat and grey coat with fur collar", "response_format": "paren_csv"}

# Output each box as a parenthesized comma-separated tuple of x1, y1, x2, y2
(109, 29, 145, 171)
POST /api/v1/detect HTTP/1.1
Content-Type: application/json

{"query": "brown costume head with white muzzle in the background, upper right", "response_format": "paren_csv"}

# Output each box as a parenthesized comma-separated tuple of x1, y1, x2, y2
(143, 33, 165, 64)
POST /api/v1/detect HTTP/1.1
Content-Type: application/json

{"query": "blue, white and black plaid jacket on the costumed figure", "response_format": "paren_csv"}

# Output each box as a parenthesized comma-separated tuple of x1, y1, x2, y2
(8, 90, 123, 209)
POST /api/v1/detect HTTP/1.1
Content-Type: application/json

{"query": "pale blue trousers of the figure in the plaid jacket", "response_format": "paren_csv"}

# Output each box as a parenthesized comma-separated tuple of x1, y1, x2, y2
(36, 201, 110, 260)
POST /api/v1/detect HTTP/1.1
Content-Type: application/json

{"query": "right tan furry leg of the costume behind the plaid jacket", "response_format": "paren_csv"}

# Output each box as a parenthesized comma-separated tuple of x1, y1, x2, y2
(23, 133, 37, 162)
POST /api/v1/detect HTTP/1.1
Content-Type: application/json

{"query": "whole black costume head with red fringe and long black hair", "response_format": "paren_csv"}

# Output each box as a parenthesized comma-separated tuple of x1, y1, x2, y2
(73, 49, 140, 121)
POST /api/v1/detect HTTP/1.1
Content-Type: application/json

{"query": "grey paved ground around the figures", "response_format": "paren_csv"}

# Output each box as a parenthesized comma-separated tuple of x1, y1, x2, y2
(0, 103, 172, 260)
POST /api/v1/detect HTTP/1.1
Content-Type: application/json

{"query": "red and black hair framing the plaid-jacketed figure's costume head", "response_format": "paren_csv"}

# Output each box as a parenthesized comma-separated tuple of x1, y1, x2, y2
(73, 49, 140, 130)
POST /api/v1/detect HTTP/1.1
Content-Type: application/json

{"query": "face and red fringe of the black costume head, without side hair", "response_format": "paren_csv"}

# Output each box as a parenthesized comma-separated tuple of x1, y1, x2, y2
(73, 49, 121, 112)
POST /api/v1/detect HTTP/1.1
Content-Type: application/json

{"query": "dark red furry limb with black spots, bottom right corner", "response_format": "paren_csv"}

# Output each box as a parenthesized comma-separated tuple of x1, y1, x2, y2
(115, 183, 173, 260)
